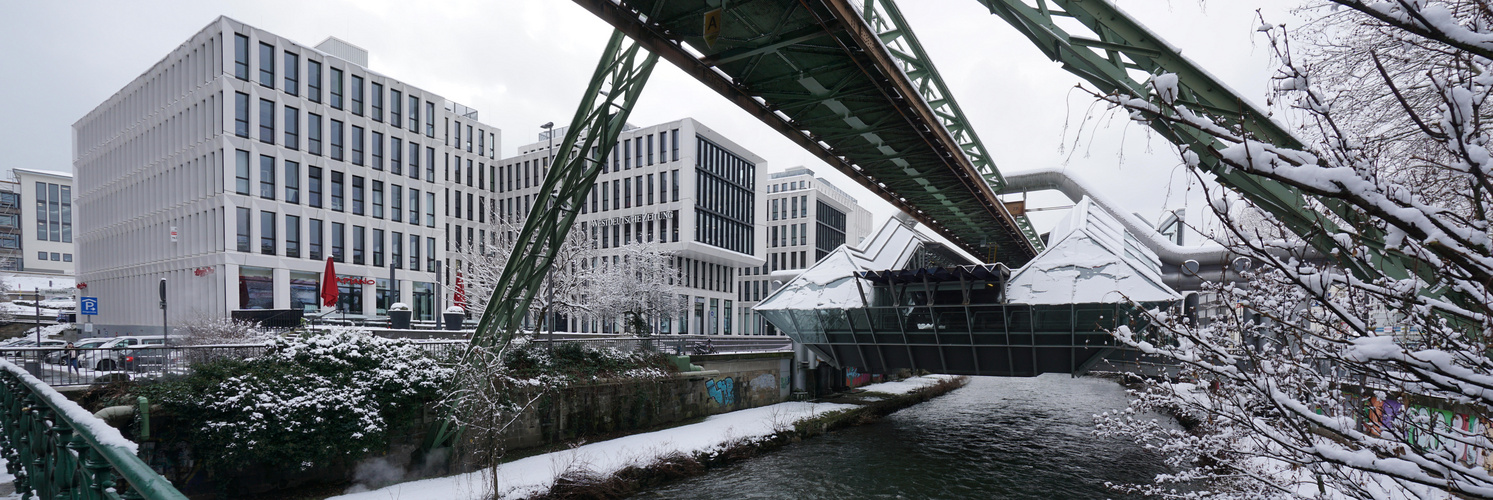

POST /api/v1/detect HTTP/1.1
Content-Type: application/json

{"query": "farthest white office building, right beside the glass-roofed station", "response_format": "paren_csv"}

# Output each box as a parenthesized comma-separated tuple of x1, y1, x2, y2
(738, 167, 870, 334)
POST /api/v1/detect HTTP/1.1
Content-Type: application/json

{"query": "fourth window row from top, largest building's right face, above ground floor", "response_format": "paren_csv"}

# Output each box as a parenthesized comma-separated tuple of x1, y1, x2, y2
(236, 207, 436, 272)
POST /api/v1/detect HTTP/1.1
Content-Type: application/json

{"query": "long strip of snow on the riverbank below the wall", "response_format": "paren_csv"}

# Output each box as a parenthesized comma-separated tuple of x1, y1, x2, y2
(328, 402, 859, 500)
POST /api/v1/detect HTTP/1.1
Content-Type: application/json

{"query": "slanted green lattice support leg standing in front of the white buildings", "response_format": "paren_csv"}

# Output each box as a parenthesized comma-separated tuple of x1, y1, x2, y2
(472, 31, 658, 349)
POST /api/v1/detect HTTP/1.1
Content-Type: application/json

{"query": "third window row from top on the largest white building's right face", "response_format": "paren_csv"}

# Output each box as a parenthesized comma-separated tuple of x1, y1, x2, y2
(233, 149, 436, 227)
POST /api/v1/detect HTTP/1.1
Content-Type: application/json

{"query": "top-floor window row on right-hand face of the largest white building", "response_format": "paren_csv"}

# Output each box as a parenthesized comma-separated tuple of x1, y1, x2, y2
(233, 33, 497, 158)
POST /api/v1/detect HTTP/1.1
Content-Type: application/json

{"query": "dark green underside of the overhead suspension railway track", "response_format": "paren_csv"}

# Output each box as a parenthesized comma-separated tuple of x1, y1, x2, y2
(575, 0, 1038, 266)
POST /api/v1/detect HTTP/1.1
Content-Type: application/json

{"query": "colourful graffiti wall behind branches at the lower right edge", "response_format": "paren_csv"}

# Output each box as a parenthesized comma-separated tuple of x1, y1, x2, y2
(1360, 397, 1493, 470)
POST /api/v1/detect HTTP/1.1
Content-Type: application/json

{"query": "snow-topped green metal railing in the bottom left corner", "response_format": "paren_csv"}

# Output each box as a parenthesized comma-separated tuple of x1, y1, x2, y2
(0, 361, 187, 500)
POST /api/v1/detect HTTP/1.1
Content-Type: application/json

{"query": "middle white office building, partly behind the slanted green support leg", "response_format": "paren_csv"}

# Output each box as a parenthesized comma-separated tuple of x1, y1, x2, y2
(495, 118, 766, 334)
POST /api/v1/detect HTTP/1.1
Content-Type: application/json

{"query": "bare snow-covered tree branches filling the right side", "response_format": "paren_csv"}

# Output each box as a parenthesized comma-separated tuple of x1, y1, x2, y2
(1096, 0, 1493, 499)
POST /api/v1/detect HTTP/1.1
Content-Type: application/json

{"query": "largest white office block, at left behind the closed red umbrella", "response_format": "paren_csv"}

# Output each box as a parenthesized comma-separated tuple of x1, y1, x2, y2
(73, 18, 499, 333)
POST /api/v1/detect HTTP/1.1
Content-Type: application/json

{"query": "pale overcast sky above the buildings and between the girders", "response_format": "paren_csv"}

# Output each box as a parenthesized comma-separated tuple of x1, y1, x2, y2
(0, 0, 1294, 243)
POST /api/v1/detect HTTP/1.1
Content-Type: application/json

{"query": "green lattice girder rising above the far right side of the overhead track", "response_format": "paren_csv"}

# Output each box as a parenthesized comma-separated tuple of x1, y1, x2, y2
(860, 0, 1044, 251)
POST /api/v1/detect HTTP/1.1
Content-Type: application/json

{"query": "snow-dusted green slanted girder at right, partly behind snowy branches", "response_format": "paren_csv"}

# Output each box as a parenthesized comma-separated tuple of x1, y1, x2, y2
(976, 0, 1438, 284)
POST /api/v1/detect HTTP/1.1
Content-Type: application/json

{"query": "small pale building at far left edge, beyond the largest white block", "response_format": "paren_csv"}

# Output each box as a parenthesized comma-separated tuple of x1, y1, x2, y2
(14, 169, 76, 276)
